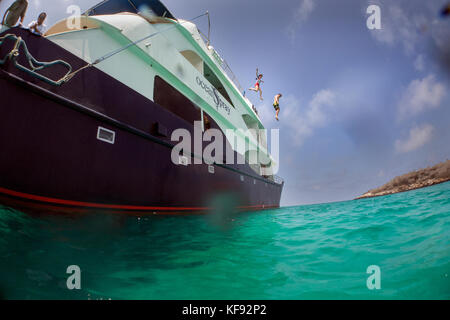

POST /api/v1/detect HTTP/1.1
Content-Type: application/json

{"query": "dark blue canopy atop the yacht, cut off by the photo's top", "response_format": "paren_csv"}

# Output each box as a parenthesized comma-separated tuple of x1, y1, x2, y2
(85, 0, 176, 20)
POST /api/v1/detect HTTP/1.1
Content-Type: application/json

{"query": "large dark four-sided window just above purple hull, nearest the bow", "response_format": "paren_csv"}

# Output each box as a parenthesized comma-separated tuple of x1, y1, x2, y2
(153, 76, 201, 124)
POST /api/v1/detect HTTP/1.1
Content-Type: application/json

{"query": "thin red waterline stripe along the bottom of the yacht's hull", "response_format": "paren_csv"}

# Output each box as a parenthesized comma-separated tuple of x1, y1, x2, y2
(0, 187, 275, 211)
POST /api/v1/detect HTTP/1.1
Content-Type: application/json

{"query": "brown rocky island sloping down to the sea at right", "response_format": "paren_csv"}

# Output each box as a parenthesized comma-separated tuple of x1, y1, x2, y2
(355, 160, 450, 200)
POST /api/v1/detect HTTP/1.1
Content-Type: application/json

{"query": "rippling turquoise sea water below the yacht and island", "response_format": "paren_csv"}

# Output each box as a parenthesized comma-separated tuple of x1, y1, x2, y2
(0, 183, 450, 299)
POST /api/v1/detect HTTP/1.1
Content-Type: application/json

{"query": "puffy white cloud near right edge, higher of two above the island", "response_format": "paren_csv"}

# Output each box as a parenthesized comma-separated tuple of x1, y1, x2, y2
(398, 75, 446, 118)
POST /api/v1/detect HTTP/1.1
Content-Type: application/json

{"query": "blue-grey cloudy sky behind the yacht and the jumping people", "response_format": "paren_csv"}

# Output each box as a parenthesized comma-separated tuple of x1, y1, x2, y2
(0, 0, 450, 206)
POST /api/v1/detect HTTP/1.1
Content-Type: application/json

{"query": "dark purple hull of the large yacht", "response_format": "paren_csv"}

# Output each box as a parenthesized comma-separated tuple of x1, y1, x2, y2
(0, 29, 283, 214)
